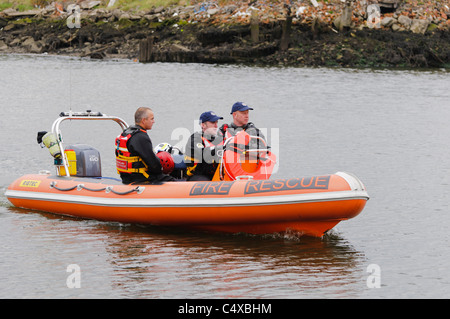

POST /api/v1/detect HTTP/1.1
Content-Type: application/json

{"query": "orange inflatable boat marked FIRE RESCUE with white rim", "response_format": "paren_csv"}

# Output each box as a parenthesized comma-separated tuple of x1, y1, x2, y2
(5, 113, 369, 237)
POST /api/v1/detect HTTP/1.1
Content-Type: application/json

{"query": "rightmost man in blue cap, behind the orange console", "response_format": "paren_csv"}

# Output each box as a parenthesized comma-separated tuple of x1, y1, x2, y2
(220, 102, 266, 148)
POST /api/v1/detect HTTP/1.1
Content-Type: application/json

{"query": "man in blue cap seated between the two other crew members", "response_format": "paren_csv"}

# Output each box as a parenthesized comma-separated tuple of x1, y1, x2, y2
(184, 111, 223, 181)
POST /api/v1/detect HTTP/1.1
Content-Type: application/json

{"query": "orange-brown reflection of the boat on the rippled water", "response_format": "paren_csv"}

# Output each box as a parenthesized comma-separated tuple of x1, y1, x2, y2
(97, 226, 363, 298)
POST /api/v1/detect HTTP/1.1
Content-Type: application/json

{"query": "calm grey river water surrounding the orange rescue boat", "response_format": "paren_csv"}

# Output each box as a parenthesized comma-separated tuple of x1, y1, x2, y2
(0, 55, 450, 299)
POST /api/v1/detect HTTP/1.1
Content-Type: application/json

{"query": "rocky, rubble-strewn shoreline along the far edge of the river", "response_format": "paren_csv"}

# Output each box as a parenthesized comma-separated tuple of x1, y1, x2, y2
(0, 0, 450, 69)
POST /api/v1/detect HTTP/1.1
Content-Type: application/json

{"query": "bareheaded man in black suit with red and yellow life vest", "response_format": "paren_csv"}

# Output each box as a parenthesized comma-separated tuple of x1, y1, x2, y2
(116, 107, 174, 184)
